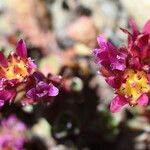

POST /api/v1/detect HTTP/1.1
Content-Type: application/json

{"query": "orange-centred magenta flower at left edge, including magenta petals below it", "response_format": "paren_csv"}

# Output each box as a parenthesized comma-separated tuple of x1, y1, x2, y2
(0, 39, 36, 107)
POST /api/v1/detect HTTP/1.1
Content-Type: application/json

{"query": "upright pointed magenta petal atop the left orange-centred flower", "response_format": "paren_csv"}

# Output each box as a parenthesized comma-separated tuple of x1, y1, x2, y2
(16, 39, 27, 59)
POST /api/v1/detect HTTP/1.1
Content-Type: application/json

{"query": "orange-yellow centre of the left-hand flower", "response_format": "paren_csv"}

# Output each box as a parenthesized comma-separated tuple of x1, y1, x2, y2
(3, 57, 29, 82)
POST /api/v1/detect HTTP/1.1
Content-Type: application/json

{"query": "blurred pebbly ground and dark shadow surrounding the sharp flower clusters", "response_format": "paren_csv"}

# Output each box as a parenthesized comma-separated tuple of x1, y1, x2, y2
(0, 0, 150, 150)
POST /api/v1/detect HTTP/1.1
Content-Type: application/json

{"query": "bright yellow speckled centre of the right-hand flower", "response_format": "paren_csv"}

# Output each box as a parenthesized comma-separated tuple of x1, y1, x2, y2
(117, 69, 150, 105)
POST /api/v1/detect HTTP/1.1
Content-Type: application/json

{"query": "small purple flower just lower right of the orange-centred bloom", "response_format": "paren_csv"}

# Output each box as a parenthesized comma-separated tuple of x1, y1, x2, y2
(22, 72, 59, 104)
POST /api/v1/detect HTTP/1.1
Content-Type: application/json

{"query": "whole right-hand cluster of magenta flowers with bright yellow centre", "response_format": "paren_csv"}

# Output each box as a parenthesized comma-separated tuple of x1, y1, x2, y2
(93, 19, 150, 112)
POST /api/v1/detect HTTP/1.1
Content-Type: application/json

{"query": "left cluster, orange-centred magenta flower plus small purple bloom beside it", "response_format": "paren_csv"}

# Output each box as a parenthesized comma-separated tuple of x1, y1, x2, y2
(0, 39, 58, 107)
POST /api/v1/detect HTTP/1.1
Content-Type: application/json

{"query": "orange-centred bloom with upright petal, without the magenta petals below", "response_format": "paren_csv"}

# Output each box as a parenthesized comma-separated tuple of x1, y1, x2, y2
(0, 40, 36, 87)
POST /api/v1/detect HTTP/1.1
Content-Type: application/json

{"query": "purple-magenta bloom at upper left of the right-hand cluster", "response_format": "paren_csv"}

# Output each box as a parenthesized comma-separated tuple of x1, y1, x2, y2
(93, 36, 126, 71)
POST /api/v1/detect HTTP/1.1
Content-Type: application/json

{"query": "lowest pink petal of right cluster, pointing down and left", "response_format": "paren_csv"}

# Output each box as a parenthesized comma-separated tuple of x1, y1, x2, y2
(110, 96, 128, 113)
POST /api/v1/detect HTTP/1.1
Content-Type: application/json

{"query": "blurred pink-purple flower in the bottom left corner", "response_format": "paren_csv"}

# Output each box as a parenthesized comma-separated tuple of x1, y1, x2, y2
(0, 115, 26, 150)
